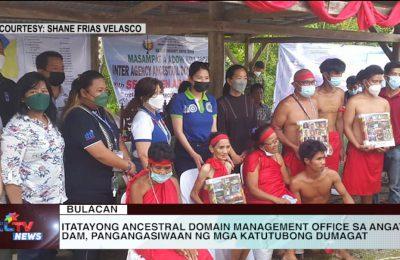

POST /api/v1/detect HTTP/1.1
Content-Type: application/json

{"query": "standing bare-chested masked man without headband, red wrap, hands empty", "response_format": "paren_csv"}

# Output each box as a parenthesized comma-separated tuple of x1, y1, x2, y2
(315, 58, 346, 171)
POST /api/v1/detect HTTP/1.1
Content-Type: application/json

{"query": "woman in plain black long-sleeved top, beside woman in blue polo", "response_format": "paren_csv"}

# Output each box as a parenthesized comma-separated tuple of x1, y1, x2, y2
(217, 65, 257, 167)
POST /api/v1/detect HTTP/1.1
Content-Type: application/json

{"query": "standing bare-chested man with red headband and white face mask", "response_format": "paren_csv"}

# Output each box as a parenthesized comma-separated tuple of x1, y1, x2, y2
(272, 69, 318, 176)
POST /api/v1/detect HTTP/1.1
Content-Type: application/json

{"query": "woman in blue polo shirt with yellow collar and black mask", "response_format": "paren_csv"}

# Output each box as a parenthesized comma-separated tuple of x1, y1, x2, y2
(171, 61, 217, 175)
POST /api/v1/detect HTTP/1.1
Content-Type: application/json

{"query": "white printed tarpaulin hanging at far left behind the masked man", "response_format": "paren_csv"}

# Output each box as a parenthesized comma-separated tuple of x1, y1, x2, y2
(2, 34, 90, 107)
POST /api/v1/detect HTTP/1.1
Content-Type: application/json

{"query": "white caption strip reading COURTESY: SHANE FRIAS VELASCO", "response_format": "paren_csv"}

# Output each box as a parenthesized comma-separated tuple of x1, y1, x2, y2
(0, 23, 146, 34)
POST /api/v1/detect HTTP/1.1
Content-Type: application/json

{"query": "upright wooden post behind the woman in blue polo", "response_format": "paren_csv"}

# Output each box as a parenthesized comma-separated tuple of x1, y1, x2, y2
(208, 1, 225, 98)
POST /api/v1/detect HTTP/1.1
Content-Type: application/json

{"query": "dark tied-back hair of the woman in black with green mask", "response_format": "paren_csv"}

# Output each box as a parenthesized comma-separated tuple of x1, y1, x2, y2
(62, 70, 104, 120)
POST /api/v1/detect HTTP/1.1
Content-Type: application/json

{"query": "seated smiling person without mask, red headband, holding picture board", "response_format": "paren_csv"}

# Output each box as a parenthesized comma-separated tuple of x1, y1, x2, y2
(190, 132, 234, 204)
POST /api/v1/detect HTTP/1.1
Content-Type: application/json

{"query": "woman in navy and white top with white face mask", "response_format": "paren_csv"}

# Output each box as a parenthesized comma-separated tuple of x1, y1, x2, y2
(127, 78, 171, 171)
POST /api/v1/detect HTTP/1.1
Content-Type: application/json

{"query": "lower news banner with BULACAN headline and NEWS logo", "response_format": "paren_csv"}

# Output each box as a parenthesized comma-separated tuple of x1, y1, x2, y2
(0, 205, 400, 249)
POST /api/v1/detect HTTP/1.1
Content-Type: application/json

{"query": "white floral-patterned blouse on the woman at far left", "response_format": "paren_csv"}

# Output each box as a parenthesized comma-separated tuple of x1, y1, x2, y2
(1, 114, 67, 204)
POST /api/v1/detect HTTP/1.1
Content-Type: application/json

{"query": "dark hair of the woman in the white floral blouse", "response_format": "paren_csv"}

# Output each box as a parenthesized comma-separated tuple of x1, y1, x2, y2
(17, 71, 57, 125)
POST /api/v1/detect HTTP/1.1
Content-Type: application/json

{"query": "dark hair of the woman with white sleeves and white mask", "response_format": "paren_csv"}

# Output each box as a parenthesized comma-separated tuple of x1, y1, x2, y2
(121, 77, 163, 118)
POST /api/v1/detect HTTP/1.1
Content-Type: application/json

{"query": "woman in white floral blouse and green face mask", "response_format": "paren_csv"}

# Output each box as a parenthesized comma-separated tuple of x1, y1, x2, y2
(0, 72, 63, 259)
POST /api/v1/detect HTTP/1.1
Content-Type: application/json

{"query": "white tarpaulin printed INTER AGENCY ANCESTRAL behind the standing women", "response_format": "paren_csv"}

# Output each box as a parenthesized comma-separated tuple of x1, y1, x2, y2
(102, 35, 208, 105)
